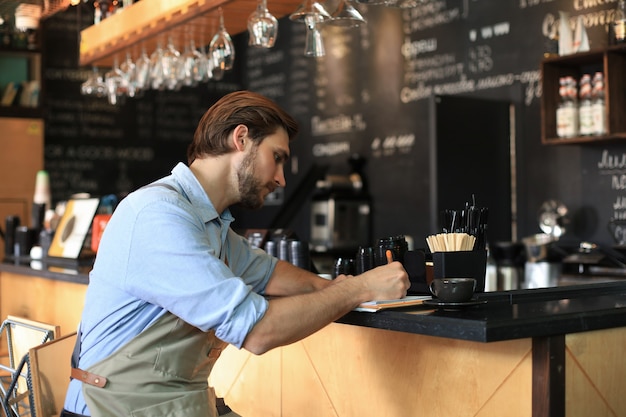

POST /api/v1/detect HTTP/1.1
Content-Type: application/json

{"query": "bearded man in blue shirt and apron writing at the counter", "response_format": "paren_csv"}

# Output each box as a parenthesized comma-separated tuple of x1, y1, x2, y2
(62, 91, 409, 417)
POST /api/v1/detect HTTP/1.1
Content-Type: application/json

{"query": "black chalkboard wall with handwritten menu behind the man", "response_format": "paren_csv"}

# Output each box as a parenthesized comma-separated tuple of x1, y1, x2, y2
(37, 0, 625, 246)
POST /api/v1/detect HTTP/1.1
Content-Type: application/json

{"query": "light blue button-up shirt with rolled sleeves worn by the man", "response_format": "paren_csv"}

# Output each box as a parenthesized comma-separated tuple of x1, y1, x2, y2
(65, 163, 276, 414)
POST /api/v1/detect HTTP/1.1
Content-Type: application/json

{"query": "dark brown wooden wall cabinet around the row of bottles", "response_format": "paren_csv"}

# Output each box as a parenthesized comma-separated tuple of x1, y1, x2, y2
(541, 45, 626, 145)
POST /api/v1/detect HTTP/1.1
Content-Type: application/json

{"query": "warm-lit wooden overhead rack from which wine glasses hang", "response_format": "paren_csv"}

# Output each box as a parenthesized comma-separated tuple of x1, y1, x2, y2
(79, 0, 300, 66)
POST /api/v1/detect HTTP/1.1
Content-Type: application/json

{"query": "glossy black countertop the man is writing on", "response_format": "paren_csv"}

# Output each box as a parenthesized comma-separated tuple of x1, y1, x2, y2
(338, 281, 626, 342)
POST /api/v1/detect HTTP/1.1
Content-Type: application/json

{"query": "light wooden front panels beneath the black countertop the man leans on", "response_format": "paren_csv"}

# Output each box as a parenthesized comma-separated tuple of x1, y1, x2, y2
(209, 320, 626, 417)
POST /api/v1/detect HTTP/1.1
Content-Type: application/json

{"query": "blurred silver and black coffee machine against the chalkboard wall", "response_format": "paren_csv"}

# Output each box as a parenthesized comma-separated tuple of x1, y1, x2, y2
(310, 156, 371, 254)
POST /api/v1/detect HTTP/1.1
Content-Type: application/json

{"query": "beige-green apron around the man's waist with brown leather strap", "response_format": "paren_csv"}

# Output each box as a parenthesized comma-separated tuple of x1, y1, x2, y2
(78, 313, 237, 417)
